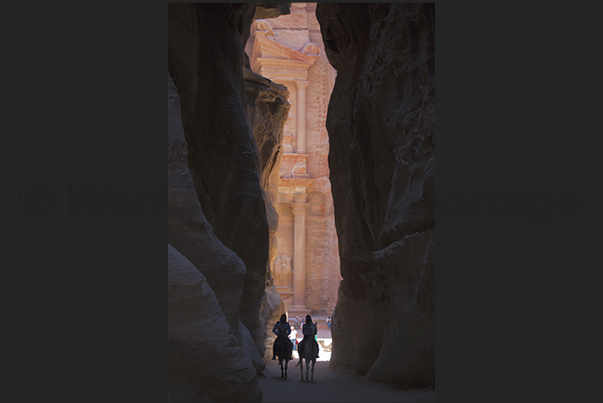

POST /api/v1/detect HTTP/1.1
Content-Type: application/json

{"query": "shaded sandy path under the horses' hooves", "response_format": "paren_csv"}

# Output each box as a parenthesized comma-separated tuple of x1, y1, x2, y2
(259, 359, 435, 403)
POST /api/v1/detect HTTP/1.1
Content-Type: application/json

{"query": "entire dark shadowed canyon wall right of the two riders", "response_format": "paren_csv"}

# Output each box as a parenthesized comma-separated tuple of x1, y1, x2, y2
(317, 3, 435, 387)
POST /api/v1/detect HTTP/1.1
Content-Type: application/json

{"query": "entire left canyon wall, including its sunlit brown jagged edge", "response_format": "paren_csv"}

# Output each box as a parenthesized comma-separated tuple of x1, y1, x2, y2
(168, 3, 288, 402)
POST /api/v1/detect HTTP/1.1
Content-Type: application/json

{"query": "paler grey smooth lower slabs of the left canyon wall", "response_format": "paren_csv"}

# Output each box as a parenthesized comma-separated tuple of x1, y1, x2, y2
(168, 71, 265, 402)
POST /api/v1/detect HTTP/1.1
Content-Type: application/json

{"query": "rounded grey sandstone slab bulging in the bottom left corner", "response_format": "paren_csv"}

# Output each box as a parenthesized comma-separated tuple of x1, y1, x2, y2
(168, 244, 262, 402)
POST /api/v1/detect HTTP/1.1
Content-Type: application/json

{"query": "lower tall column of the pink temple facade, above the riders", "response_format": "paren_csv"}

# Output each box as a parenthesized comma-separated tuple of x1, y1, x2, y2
(291, 203, 307, 311)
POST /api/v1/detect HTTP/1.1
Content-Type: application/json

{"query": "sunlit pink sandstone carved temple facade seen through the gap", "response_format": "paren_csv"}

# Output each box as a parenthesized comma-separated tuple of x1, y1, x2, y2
(245, 3, 341, 317)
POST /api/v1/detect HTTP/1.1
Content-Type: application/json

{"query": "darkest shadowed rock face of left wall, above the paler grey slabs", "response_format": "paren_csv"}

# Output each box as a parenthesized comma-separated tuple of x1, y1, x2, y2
(168, 3, 280, 362)
